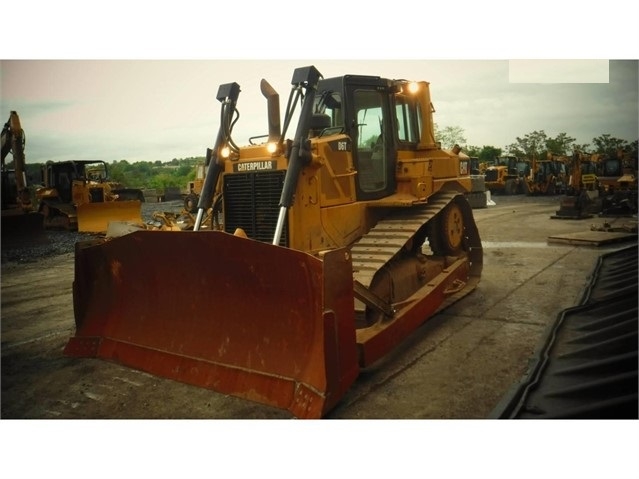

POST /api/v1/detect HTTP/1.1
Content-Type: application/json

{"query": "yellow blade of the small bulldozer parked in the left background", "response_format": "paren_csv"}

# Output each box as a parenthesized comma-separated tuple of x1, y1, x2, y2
(77, 200, 142, 233)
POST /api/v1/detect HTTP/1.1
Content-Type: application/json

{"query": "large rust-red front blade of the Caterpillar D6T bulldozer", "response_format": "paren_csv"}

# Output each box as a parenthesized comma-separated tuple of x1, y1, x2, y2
(65, 230, 359, 418)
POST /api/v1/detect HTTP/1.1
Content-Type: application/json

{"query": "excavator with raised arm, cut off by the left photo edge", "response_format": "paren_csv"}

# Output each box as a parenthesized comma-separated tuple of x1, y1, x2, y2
(0, 111, 44, 246)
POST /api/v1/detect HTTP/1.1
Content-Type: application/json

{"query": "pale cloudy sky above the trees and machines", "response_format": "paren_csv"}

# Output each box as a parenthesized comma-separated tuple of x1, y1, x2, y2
(0, 59, 639, 162)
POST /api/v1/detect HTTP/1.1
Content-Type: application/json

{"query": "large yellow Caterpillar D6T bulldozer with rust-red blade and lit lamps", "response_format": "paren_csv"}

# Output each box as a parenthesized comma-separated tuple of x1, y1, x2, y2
(65, 66, 482, 418)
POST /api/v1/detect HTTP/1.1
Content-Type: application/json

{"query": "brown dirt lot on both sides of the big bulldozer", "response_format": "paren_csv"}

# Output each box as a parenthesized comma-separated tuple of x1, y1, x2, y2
(2, 196, 628, 419)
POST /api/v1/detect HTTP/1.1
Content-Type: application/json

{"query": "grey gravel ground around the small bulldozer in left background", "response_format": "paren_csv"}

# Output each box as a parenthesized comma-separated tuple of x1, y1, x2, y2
(1, 200, 184, 268)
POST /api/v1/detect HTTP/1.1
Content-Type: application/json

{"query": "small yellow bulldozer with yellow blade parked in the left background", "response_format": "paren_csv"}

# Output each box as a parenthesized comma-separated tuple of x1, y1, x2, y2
(36, 160, 144, 233)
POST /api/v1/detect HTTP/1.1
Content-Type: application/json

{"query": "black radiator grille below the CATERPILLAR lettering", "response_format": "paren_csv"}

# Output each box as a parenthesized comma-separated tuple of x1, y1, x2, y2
(224, 170, 288, 246)
